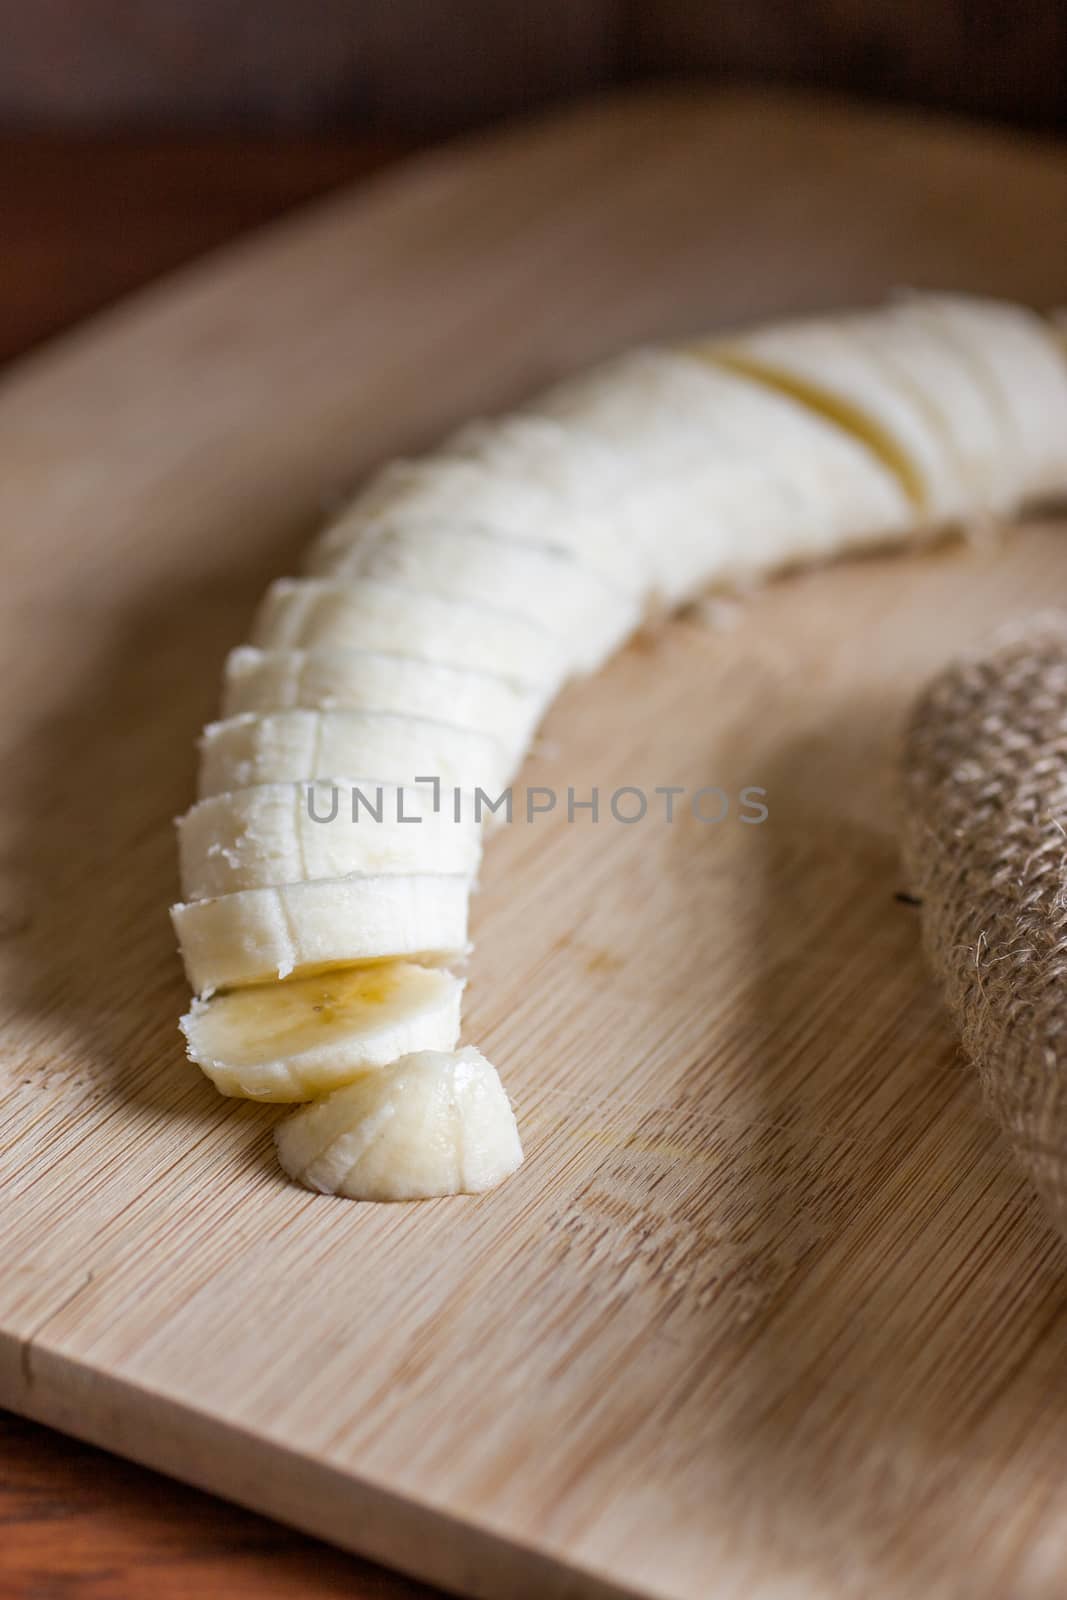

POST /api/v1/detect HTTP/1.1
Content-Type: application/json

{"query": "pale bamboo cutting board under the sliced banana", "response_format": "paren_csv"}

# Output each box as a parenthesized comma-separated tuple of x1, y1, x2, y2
(0, 93, 1067, 1600)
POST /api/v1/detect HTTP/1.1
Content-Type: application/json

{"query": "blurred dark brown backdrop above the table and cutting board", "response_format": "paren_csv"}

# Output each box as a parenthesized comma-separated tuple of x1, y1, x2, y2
(0, 0, 1067, 136)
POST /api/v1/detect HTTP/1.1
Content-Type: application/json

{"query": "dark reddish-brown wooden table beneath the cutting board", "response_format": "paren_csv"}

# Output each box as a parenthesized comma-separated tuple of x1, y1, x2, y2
(0, 138, 434, 1600)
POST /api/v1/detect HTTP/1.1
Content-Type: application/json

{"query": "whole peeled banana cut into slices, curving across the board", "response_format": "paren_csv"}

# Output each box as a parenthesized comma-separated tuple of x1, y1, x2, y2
(173, 294, 1067, 1200)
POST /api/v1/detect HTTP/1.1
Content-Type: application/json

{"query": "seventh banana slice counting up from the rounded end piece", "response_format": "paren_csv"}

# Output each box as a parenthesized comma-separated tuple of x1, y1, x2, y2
(251, 578, 568, 699)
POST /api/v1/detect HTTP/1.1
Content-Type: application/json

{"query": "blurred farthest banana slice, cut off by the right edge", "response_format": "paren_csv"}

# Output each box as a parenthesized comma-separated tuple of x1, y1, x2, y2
(917, 294, 1067, 499)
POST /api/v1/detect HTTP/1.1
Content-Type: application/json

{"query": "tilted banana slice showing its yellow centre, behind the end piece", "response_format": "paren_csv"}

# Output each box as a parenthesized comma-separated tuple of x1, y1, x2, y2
(181, 962, 464, 1101)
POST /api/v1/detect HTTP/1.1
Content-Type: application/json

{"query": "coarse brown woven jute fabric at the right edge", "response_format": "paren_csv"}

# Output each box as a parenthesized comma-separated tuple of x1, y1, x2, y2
(902, 616, 1067, 1235)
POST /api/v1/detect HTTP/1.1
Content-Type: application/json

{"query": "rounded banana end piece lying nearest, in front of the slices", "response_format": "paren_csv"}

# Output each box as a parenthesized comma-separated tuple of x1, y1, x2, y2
(275, 1048, 523, 1200)
